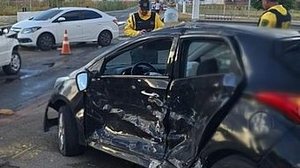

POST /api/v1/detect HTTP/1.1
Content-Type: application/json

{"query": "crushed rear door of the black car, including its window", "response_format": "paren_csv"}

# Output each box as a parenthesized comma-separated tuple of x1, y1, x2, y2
(164, 36, 242, 167)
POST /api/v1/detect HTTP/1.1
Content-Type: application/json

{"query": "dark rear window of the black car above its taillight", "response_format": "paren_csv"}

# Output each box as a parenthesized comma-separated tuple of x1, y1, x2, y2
(280, 40, 300, 74)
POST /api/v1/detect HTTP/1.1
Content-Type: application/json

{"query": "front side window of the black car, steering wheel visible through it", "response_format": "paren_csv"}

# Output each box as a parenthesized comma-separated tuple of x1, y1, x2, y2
(103, 38, 172, 76)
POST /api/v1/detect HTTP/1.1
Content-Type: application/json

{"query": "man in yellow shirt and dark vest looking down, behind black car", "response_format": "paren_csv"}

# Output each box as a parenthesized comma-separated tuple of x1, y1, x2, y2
(124, 0, 164, 37)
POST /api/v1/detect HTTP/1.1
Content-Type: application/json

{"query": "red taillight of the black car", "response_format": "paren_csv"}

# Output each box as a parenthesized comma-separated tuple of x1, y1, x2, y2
(255, 92, 300, 123)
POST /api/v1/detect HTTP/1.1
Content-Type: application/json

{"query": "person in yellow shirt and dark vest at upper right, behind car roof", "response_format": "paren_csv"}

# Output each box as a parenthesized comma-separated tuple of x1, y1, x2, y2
(258, 0, 291, 29)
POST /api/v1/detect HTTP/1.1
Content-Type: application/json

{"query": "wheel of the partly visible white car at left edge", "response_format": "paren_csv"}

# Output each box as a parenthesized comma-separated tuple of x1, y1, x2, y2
(2, 51, 22, 75)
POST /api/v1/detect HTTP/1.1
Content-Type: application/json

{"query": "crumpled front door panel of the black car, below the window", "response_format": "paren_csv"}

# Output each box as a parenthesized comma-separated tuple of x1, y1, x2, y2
(87, 78, 168, 160)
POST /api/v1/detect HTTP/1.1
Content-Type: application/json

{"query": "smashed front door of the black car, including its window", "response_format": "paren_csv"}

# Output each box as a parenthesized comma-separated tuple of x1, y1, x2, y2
(86, 36, 176, 159)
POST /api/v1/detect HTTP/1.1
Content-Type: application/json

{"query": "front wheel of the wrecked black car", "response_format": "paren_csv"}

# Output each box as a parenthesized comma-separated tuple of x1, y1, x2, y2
(57, 106, 84, 156)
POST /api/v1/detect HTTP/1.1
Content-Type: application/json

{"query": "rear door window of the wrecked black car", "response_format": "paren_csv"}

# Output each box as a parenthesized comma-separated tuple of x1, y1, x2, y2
(183, 39, 236, 77)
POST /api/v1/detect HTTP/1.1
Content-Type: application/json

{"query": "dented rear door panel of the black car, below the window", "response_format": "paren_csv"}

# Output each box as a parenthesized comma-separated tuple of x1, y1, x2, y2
(162, 74, 237, 168)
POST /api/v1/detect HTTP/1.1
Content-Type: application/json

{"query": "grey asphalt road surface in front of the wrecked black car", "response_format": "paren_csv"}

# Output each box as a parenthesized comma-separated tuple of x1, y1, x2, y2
(0, 42, 144, 168)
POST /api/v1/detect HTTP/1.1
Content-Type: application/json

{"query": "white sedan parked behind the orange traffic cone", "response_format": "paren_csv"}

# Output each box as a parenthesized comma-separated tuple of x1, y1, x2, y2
(11, 7, 119, 50)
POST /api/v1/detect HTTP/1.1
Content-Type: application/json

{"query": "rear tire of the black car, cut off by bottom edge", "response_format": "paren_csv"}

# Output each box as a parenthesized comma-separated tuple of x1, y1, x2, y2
(211, 155, 257, 168)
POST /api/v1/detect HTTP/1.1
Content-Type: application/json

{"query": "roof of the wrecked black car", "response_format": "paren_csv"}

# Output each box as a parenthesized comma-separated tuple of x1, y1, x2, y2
(155, 22, 300, 39)
